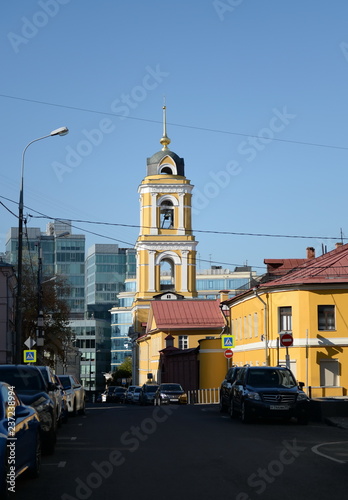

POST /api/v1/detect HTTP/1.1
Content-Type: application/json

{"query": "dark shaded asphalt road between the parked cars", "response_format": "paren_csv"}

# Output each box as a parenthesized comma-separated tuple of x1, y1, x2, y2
(10, 404, 348, 500)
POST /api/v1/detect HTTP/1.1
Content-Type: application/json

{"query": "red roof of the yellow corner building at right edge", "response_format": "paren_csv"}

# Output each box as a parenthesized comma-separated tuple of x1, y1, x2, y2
(260, 244, 348, 288)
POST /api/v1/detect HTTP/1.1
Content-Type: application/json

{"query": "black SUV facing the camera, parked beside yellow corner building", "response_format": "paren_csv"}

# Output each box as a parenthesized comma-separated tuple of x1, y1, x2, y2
(229, 366, 309, 424)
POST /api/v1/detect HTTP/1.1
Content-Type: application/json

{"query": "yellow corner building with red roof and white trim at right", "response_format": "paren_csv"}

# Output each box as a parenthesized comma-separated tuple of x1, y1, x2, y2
(224, 245, 348, 397)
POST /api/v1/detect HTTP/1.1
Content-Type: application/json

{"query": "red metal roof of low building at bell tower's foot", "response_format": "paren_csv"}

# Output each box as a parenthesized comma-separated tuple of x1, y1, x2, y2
(151, 300, 225, 330)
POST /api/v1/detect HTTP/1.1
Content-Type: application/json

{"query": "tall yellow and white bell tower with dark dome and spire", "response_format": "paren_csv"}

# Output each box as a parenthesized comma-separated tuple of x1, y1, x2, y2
(135, 106, 197, 306)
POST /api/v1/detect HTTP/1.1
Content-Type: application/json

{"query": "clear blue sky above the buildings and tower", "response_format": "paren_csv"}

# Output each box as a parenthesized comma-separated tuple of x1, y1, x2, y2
(0, 0, 348, 272)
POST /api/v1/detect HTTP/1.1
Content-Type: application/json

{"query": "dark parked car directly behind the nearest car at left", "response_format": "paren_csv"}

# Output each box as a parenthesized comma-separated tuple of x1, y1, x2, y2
(0, 365, 57, 453)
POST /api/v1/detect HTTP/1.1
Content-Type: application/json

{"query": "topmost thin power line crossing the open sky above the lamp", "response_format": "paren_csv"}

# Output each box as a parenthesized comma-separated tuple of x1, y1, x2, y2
(0, 94, 348, 151)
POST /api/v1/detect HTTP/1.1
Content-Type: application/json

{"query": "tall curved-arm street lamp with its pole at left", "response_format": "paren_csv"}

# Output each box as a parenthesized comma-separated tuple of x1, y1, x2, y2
(16, 127, 69, 364)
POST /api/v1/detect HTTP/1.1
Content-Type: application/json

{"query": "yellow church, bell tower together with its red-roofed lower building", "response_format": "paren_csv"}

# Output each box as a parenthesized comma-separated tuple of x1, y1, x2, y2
(125, 107, 226, 385)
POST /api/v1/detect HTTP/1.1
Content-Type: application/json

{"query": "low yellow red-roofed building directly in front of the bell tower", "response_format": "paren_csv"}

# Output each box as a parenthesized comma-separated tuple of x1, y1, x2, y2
(137, 292, 226, 390)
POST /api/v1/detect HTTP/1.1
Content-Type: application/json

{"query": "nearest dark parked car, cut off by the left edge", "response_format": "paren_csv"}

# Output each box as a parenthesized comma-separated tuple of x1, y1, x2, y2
(0, 382, 41, 499)
